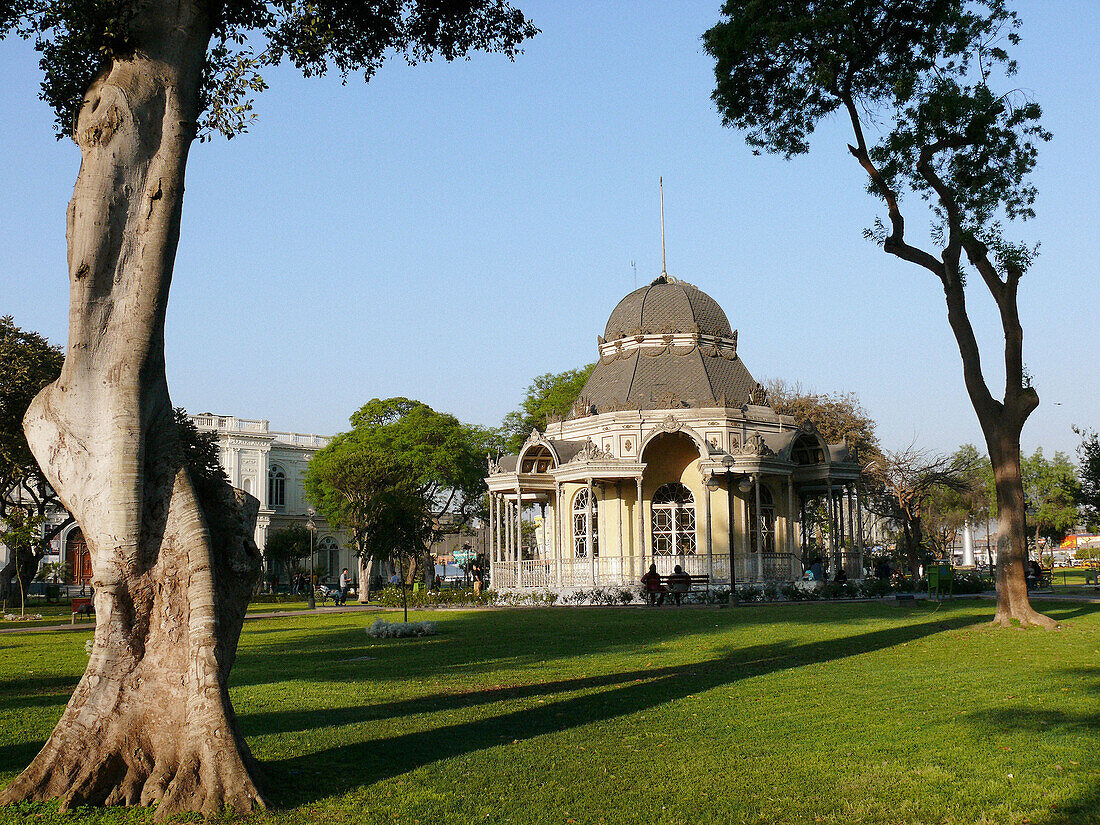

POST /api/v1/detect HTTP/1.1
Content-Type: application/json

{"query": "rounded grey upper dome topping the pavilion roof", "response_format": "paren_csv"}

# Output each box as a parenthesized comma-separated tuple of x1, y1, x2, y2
(604, 275, 734, 341)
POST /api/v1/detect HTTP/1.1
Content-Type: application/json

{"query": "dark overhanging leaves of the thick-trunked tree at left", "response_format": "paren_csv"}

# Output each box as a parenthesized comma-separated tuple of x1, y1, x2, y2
(0, 0, 538, 138)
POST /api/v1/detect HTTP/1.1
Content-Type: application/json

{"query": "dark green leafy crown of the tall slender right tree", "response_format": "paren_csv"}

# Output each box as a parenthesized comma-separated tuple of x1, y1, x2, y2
(704, 0, 1049, 245)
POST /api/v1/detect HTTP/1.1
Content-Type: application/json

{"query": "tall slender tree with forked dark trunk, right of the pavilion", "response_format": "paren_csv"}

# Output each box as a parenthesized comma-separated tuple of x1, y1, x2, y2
(704, 0, 1055, 627)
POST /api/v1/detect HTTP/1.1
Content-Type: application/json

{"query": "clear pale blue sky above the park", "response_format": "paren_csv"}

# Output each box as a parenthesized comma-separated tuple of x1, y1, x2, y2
(0, 0, 1100, 459)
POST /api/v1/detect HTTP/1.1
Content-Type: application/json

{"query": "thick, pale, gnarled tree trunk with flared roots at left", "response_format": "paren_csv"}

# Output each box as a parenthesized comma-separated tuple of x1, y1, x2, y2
(0, 0, 263, 821)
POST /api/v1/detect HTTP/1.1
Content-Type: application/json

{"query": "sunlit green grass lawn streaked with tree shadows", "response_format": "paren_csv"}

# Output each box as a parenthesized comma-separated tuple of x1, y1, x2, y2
(0, 602, 1100, 825)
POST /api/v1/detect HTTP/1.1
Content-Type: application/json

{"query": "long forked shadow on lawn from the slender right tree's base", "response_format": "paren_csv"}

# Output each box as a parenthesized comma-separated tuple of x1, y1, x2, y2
(259, 615, 982, 806)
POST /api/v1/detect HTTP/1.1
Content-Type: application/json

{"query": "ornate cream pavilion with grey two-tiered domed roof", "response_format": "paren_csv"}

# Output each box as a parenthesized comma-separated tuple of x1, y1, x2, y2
(486, 275, 862, 590)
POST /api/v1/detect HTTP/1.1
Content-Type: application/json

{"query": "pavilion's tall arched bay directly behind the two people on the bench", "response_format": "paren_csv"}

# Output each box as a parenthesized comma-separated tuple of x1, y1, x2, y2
(639, 429, 715, 575)
